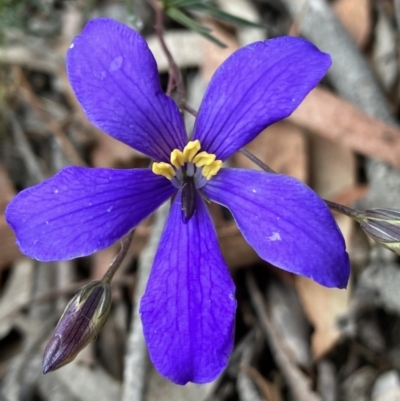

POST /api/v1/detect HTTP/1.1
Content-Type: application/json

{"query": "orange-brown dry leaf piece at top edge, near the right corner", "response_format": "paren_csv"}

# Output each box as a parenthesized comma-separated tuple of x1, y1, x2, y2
(333, 0, 372, 47)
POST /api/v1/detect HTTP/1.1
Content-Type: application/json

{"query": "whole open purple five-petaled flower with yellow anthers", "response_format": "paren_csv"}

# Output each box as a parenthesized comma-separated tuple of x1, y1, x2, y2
(6, 19, 349, 384)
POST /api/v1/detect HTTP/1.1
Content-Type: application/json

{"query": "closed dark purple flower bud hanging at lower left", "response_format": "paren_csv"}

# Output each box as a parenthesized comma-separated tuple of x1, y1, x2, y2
(43, 281, 111, 374)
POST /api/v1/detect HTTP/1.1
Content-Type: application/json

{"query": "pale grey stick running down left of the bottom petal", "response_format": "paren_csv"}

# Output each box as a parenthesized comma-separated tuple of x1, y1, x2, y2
(122, 202, 169, 401)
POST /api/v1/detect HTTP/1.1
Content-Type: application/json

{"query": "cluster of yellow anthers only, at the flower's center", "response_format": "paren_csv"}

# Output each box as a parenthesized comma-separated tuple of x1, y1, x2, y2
(152, 139, 222, 180)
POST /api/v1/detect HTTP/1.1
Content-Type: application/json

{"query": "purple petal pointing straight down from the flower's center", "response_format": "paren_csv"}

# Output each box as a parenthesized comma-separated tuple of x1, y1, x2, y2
(140, 194, 236, 384)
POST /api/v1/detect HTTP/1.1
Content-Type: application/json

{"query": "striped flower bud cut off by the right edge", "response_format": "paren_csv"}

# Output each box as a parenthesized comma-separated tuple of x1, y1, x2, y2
(356, 208, 400, 255)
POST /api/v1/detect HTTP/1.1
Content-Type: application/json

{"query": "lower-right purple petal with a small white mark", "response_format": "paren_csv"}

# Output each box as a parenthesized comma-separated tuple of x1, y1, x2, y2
(203, 169, 350, 288)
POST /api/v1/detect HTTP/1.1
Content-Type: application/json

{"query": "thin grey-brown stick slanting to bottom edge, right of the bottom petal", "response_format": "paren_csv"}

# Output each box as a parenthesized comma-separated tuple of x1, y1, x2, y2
(246, 273, 321, 401)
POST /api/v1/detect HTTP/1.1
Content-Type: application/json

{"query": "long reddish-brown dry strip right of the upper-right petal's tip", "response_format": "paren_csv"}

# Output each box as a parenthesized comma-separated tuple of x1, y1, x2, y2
(289, 88, 400, 167)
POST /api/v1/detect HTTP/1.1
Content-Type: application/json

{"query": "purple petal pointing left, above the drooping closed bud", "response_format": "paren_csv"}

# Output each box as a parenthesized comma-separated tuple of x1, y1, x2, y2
(6, 167, 176, 261)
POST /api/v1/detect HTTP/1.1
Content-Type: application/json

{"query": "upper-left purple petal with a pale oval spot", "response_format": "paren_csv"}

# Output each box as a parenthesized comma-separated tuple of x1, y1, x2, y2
(67, 18, 186, 161)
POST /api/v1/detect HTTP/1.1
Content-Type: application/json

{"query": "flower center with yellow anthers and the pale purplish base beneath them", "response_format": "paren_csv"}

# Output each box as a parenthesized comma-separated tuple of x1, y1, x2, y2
(152, 140, 222, 189)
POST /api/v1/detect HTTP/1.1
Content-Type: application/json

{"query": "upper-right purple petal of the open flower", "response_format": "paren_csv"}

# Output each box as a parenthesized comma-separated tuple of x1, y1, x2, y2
(193, 36, 331, 160)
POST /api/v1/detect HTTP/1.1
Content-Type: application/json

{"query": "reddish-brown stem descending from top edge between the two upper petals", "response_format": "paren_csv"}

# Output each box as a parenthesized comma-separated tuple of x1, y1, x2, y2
(148, 0, 186, 110)
